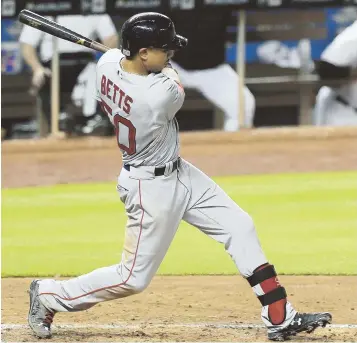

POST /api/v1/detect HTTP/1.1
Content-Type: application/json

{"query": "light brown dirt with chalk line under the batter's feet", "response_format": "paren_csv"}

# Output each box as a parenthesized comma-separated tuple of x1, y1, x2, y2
(2, 276, 357, 342)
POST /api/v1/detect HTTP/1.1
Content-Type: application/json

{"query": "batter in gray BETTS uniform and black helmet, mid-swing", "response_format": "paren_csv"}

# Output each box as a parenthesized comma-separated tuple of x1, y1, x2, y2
(28, 12, 332, 341)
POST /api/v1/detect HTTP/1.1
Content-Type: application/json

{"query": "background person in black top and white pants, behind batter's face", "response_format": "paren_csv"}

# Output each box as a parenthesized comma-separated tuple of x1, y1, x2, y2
(170, 11, 255, 131)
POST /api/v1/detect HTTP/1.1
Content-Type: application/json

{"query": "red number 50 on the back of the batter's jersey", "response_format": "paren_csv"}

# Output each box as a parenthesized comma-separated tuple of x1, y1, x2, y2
(100, 100, 136, 155)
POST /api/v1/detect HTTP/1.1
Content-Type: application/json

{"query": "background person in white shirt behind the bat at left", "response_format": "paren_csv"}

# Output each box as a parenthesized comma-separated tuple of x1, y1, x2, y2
(19, 14, 118, 137)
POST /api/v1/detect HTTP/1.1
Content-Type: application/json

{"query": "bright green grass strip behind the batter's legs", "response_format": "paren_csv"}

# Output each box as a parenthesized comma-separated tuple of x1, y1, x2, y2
(2, 172, 357, 276)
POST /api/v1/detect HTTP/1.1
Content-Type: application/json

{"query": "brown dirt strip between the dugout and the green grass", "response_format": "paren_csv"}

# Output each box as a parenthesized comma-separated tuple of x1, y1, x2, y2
(2, 127, 357, 187)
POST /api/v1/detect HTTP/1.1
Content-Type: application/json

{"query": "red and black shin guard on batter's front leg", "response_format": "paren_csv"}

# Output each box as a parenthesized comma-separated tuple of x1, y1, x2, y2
(247, 263, 292, 325)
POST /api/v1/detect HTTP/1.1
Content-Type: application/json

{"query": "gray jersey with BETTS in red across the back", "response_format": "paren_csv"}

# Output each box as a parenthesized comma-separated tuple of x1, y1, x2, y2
(96, 49, 185, 167)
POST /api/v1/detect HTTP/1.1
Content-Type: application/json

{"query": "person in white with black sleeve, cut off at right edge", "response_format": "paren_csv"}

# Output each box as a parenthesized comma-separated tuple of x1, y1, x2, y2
(314, 20, 357, 126)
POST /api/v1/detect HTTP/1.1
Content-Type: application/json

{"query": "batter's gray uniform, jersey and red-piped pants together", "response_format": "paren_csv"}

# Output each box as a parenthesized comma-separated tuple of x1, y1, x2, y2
(39, 50, 296, 336)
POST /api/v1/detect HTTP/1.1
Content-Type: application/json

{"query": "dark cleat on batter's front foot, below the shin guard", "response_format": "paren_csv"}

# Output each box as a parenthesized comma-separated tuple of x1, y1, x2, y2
(268, 312, 332, 342)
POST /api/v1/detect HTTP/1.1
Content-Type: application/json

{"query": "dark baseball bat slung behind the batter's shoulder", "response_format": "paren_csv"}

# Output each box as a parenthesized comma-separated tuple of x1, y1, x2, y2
(19, 10, 110, 52)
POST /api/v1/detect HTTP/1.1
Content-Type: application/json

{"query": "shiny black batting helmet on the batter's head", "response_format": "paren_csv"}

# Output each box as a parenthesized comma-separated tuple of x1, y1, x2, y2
(120, 12, 187, 57)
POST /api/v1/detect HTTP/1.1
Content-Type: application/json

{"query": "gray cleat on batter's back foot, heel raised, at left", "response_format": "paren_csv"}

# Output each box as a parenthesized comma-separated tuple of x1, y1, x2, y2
(28, 280, 55, 338)
